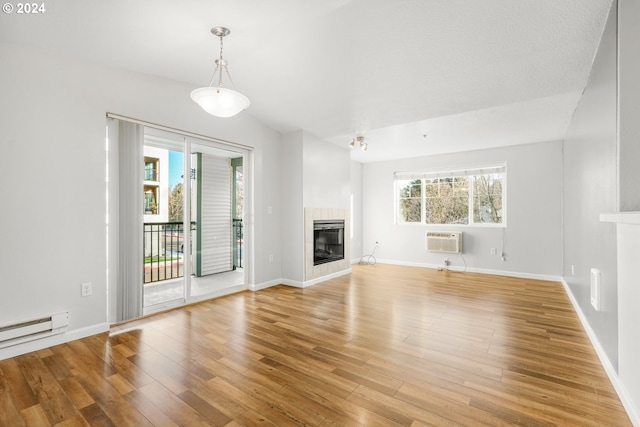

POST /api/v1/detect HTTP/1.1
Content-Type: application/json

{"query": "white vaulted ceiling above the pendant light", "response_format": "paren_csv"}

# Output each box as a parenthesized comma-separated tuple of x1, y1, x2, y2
(0, 0, 611, 162)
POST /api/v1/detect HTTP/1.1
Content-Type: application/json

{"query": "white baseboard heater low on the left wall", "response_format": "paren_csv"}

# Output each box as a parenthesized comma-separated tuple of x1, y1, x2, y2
(0, 311, 69, 348)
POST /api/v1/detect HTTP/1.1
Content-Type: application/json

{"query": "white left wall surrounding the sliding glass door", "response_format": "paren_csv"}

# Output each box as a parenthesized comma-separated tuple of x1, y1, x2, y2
(0, 45, 281, 357)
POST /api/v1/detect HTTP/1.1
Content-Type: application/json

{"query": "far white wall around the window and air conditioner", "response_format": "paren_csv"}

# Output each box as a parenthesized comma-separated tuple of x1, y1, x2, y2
(363, 141, 562, 277)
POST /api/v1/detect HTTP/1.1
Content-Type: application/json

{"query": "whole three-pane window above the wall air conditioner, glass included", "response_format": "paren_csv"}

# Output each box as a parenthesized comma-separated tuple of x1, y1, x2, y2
(395, 164, 507, 225)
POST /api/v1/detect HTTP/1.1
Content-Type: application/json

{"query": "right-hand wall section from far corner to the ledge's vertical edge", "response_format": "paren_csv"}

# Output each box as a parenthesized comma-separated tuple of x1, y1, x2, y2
(562, 0, 618, 368)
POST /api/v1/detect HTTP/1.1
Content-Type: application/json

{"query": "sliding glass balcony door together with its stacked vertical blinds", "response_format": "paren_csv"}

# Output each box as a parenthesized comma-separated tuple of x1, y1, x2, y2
(107, 116, 251, 322)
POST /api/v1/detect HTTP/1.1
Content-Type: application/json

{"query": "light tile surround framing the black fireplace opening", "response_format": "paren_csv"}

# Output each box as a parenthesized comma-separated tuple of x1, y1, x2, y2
(304, 208, 351, 282)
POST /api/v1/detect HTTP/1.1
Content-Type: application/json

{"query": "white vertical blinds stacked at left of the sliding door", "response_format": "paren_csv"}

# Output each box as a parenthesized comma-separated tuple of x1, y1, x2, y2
(107, 118, 144, 322)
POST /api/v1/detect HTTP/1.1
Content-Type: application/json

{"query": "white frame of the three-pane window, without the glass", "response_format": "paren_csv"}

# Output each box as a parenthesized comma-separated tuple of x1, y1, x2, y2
(393, 161, 507, 228)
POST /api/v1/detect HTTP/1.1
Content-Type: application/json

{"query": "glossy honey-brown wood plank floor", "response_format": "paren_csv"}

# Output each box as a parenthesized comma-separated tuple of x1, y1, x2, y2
(0, 264, 631, 427)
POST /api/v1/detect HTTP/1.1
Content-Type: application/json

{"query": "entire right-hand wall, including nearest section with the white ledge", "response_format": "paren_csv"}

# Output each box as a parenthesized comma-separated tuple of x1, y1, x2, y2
(563, 0, 640, 425)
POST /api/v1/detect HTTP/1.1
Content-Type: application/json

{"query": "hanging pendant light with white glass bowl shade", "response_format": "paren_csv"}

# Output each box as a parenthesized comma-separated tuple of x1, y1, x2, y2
(191, 27, 250, 117)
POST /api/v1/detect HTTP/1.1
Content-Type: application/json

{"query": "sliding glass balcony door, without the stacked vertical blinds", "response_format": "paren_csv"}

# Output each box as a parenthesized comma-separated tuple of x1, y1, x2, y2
(143, 127, 245, 313)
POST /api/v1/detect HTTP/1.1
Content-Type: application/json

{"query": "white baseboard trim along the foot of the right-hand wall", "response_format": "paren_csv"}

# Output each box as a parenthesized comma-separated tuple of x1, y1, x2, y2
(560, 278, 640, 427)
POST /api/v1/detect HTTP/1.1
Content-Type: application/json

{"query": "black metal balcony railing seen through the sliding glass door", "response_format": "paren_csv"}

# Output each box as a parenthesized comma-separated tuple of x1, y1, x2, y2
(143, 219, 243, 283)
